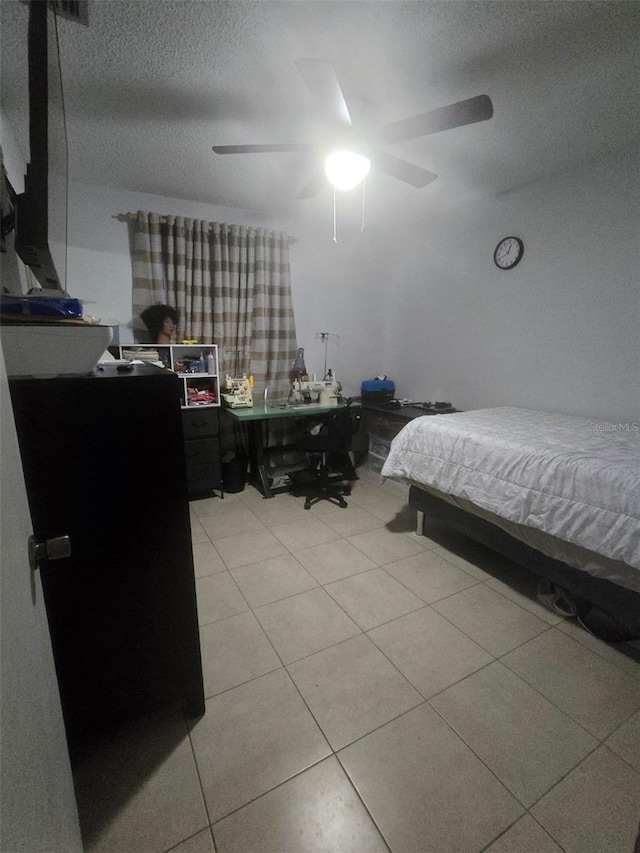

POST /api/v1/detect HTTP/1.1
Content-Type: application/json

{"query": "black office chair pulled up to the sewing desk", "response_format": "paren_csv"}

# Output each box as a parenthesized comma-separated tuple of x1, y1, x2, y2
(289, 400, 360, 509)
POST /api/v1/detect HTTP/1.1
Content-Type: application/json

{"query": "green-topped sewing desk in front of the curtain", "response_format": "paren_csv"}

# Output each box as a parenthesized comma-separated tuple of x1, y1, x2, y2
(224, 403, 360, 498)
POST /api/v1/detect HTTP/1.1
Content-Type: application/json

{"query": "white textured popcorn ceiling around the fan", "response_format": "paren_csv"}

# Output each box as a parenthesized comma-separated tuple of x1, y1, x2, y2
(0, 0, 640, 220)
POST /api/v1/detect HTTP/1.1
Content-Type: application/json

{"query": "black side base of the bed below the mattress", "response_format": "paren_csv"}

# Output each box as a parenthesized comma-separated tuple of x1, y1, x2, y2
(409, 486, 640, 637)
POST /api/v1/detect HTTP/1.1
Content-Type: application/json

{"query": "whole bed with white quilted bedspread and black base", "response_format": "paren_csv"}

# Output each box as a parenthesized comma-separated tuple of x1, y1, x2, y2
(381, 407, 640, 638)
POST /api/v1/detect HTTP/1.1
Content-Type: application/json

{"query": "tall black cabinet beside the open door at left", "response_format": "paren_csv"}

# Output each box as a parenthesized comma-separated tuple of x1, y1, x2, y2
(10, 365, 204, 748)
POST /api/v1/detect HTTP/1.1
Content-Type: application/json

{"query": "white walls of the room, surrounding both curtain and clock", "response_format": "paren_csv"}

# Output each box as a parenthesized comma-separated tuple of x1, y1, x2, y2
(2, 98, 640, 421)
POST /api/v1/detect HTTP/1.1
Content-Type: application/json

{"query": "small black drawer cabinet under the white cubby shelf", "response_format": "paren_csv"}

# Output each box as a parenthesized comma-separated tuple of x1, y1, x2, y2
(182, 406, 222, 498)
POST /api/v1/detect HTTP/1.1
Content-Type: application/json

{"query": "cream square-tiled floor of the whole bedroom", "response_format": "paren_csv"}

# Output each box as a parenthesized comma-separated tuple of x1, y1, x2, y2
(74, 471, 640, 853)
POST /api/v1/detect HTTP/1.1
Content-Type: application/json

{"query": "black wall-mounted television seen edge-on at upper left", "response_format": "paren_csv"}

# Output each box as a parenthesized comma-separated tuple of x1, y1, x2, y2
(15, 0, 68, 290)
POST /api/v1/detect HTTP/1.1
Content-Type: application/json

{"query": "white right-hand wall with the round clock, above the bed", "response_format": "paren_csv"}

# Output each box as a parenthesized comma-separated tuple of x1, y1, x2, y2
(376, 153, 640, 421)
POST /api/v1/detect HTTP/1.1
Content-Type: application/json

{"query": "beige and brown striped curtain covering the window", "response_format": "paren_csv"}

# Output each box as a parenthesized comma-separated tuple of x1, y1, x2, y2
(133, 211, 297, 400)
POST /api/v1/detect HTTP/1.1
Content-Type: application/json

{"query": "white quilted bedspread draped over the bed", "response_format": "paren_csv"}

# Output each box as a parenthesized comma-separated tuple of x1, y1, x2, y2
(382, 407, 640, 569)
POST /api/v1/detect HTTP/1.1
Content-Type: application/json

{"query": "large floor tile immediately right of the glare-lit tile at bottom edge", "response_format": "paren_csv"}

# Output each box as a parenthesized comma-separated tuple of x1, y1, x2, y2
(338, 705, 523, 853)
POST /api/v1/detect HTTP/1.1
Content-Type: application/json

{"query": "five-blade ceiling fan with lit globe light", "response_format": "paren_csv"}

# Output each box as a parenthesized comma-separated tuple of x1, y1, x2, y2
(213, 59, 493, 198)
